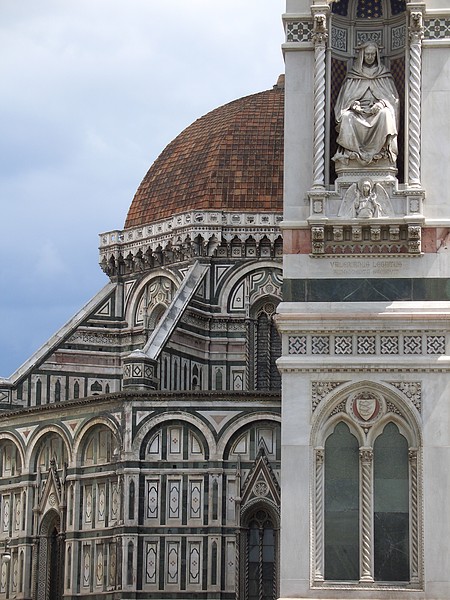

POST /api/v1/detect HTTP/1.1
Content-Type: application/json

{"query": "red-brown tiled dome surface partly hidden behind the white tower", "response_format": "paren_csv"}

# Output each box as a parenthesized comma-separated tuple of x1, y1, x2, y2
(125, 77, 284, 228)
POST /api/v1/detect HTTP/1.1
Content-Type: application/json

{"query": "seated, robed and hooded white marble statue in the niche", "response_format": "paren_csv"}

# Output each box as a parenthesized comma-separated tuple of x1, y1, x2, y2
(333, 42, 399, 166)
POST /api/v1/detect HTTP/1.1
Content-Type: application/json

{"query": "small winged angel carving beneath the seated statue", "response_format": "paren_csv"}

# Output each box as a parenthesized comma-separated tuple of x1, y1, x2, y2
(338, 177, 394, 219)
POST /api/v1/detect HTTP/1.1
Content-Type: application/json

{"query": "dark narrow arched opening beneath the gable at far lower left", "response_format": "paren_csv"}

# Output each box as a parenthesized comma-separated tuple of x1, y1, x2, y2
(36, 510, 65, 600)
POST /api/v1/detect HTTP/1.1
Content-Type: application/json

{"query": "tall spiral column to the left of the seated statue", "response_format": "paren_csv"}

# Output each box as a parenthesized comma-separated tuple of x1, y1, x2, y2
(312, 13, 328, 187)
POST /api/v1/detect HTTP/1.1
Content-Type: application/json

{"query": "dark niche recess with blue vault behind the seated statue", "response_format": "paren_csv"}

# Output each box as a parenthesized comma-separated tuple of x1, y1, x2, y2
(327, 0, 408, 182)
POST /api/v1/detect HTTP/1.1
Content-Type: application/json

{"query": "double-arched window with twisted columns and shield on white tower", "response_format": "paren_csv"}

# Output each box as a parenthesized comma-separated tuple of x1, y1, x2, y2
(311, 382, 422, 589)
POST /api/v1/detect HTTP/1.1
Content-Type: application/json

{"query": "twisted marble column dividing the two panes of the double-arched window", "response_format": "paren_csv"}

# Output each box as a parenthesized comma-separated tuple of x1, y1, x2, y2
(359, 448, 373, 582)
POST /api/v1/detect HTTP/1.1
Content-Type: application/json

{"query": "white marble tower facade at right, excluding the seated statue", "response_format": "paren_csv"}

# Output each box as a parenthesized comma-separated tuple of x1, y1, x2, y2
(277, 0, 450, 600)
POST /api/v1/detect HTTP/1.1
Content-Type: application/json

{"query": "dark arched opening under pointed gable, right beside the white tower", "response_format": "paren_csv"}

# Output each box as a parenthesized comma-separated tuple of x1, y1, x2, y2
(239, 503, 279, 600)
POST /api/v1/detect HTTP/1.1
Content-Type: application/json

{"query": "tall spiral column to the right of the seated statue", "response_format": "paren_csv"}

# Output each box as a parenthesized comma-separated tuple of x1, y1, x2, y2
(408, 11, 423, 185)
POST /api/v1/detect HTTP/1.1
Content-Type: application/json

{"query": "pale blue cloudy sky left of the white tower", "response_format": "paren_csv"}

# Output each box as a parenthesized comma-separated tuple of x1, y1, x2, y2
(0, 0, 285, 377)
